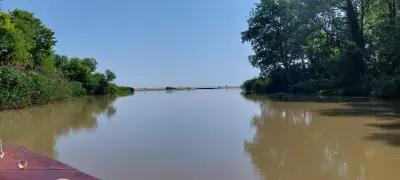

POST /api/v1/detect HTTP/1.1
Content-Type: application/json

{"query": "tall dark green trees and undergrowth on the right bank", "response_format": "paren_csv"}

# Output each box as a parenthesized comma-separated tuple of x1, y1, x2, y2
(242, 0, 400, 99)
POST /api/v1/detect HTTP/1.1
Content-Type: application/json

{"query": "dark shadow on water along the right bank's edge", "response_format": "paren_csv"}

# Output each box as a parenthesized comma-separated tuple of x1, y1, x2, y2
(244, 92, 400, 146)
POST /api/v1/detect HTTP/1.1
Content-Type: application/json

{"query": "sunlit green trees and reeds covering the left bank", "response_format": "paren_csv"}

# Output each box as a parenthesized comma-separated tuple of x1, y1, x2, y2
(0, 9, 134, 110)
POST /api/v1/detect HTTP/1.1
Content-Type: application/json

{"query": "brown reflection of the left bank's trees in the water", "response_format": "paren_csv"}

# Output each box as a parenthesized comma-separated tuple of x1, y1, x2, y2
(0, 96, 116, 157)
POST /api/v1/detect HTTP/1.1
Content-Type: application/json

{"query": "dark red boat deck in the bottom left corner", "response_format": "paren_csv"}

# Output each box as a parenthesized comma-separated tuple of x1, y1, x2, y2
(0, 146, 97, 180)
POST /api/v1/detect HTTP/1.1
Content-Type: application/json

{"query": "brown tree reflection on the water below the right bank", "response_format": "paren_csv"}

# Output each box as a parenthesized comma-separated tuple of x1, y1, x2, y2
(245, 100, 400, 180)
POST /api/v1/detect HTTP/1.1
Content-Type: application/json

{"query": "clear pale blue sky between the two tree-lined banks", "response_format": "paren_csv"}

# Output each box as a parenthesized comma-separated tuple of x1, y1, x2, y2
(1, 0, 259, 87)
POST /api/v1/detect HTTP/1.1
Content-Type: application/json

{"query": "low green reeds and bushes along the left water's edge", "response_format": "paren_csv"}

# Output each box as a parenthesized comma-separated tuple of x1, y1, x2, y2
(0, 66, 134, 110)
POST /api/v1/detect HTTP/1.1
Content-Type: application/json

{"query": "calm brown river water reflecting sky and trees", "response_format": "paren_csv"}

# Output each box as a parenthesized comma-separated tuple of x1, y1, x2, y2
(0, 90, 400, 180)
